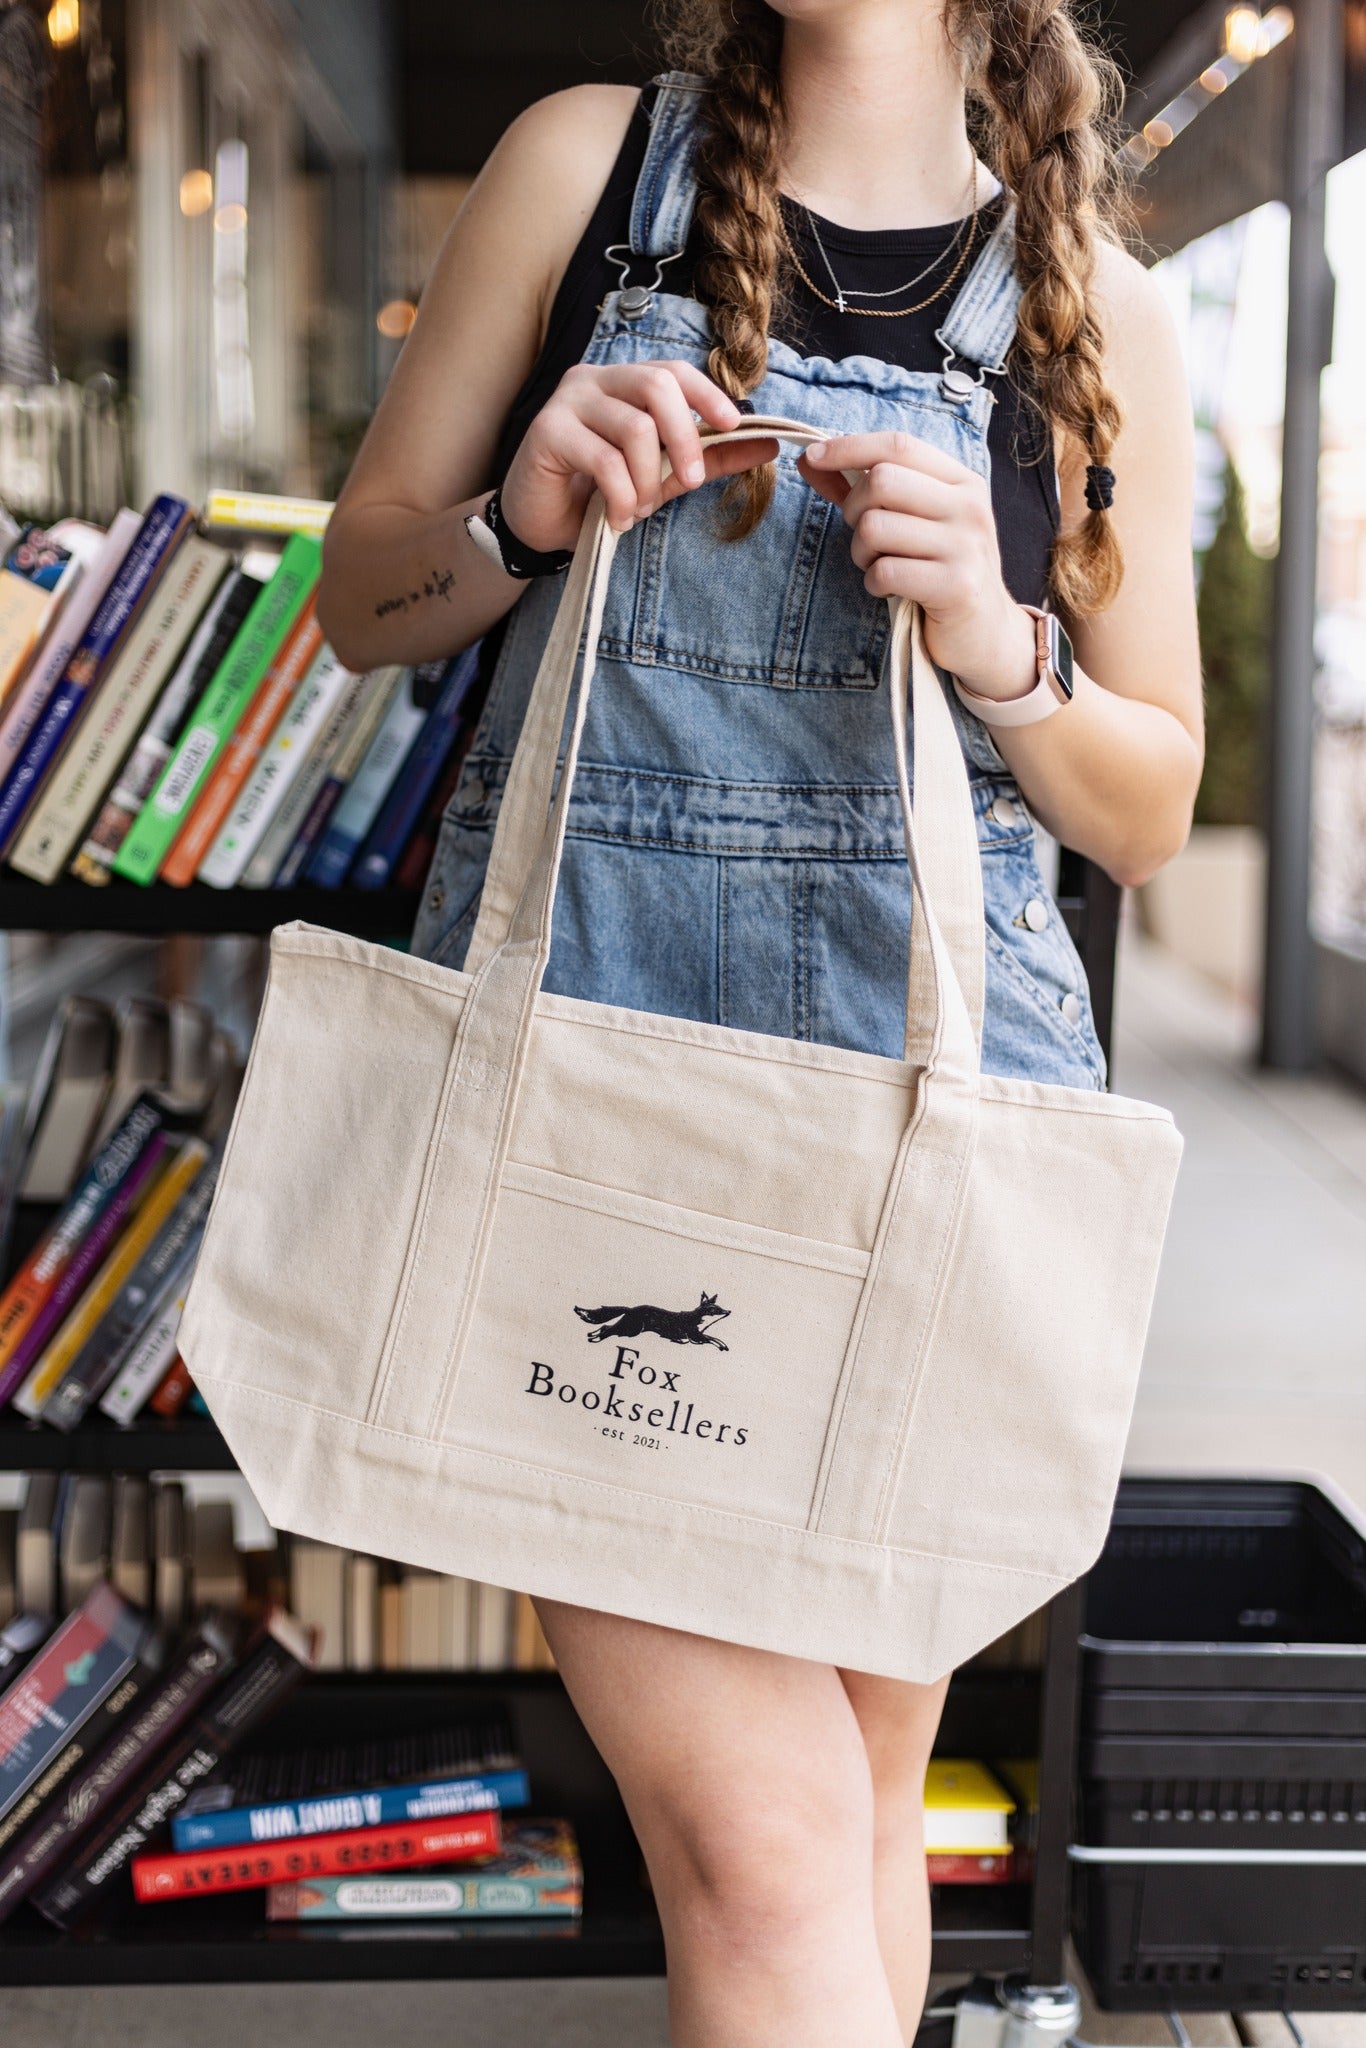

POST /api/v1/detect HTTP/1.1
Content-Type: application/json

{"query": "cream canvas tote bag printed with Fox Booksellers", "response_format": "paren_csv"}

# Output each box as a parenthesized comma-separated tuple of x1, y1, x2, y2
(180, 418, 1182, 1681)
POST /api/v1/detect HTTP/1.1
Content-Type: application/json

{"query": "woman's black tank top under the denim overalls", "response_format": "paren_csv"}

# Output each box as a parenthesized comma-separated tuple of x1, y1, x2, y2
(489, 86, 1059, 606)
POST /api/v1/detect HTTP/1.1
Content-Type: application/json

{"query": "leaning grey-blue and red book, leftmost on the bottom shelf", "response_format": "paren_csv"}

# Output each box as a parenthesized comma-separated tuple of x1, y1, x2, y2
(0, 1581, 147, 1819)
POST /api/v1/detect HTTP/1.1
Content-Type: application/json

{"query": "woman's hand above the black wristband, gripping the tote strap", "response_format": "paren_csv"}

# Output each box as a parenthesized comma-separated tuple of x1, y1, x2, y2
(502, 362, 778, 551)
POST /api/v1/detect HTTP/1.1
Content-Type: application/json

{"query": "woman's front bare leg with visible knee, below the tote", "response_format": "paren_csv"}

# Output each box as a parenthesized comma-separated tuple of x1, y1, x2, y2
(537, 1597, 901, 2048)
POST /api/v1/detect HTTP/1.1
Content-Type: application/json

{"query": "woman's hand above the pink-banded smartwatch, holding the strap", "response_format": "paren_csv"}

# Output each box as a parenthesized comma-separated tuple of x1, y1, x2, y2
(797, 432, 1038, 698)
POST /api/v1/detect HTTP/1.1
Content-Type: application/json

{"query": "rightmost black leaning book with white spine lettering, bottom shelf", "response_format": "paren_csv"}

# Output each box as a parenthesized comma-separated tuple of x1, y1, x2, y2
(33, 1612, 311, 1927)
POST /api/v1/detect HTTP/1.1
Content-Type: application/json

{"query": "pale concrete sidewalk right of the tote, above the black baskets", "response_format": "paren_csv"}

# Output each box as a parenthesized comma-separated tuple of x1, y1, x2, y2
(1110, 920, 1366, 1520)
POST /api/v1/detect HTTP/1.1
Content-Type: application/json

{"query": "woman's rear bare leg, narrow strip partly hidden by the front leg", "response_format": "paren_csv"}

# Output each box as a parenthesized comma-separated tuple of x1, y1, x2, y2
(840, 1669, 948, 2044)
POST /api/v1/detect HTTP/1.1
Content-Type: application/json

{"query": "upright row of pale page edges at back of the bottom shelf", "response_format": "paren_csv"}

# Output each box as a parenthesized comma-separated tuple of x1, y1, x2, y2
(0, 1473, 555, 1671)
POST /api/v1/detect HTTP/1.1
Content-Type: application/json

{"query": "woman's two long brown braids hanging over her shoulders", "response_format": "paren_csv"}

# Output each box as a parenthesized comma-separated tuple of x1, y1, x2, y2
(659, 0, 1124, 614)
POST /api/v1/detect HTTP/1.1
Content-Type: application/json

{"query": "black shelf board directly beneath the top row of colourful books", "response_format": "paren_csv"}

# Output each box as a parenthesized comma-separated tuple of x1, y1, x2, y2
(0, 872, 422, 938)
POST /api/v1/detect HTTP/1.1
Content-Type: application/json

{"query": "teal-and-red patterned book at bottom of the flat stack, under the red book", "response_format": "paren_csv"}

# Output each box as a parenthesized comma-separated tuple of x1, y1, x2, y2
(266, 1821, 584, 1921)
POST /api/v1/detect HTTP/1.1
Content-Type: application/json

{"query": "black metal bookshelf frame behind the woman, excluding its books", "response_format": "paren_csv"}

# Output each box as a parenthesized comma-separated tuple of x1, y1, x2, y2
(0, 848, 1120, 1987)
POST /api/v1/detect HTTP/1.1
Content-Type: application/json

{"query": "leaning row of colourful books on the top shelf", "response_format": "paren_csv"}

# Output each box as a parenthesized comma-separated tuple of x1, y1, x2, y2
(0, 494, 479, 889)
